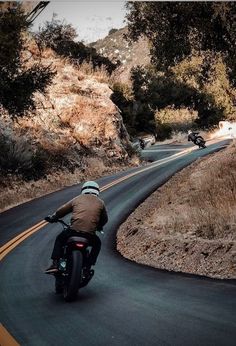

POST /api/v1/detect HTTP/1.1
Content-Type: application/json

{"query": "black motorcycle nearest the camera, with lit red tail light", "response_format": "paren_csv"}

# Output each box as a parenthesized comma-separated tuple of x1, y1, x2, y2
(45, 218, 97, 302)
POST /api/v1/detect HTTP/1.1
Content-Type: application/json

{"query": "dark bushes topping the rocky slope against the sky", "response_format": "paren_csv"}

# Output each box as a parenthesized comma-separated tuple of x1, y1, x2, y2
(35, 16, 118, 74)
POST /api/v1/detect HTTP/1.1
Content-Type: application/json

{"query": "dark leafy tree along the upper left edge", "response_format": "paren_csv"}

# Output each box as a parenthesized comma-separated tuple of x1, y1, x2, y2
(0, 4, 54, 117)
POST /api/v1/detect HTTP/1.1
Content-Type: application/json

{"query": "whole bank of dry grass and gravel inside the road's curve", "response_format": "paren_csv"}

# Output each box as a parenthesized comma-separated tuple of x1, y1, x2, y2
(117, 143, 236, 279)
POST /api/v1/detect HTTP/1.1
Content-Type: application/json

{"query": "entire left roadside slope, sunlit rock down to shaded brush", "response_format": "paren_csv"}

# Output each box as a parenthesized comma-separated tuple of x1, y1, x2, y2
(0, 42, 138, 210)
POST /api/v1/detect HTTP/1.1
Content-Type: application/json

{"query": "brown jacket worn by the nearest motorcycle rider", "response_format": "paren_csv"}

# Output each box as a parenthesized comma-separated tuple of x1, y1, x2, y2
(56, 194, 108, 234)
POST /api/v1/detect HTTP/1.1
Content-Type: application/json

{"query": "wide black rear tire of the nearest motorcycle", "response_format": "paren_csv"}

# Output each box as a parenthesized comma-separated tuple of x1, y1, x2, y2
(63, 251, 83, 302)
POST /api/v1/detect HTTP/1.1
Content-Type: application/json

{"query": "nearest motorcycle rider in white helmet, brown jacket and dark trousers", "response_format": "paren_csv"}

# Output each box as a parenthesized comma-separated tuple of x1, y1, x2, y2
(45, 181, 108, 274)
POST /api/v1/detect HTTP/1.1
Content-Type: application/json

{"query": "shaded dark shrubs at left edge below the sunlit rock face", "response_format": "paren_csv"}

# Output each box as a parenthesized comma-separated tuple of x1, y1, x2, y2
(0, 132, 80, 181)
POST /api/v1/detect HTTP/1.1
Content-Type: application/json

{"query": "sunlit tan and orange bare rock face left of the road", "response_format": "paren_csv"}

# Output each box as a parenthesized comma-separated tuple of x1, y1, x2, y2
(16, 48, 133, 160)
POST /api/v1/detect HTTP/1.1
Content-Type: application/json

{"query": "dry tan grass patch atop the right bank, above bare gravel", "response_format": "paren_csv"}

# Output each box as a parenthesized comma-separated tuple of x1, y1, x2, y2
(153, 139, 236, 240)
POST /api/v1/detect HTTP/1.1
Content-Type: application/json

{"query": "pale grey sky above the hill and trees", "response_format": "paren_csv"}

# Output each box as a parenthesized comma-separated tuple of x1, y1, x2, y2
(33, 0, 126, 43)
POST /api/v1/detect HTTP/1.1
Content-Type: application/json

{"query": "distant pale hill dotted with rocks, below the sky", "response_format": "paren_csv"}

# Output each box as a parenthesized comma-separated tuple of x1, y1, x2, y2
(91, 27, 150, 82)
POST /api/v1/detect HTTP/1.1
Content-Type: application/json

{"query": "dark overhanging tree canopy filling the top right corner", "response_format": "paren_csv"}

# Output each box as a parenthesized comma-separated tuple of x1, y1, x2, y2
(127, 1, 236, 84)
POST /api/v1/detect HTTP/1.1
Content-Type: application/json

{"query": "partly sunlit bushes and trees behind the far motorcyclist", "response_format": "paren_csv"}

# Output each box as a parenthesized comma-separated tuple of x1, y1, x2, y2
(112, 57, 236, 139)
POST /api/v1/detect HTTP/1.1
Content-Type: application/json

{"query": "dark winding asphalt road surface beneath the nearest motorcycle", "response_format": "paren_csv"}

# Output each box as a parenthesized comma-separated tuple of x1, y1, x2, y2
(0, 141, 236, 346)
